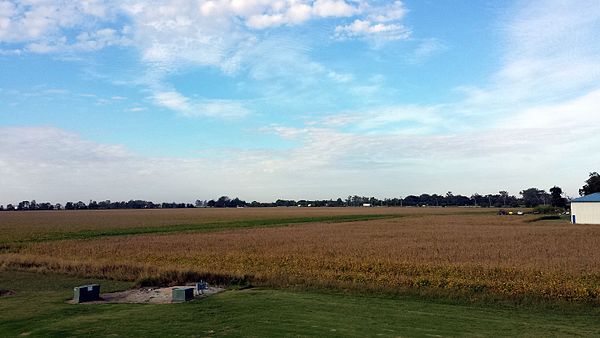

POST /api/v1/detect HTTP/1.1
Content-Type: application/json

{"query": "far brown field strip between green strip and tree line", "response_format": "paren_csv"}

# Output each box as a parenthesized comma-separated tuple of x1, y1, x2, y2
(0, 208, 460, 242)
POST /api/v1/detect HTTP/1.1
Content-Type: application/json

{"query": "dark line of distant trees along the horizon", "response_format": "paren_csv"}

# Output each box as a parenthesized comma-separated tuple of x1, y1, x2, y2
(0, 172, 600, 211)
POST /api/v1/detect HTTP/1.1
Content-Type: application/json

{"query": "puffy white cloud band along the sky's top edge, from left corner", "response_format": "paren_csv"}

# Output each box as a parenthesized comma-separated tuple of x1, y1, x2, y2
(0, 0, 408, 55)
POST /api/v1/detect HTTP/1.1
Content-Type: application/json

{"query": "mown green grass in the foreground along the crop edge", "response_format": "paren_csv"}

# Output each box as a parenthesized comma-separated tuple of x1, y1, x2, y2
(0, 271, 600, 337)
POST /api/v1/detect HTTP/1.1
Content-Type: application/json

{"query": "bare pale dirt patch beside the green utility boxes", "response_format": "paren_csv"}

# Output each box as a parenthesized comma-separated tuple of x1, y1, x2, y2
(69, 285, 225, 304)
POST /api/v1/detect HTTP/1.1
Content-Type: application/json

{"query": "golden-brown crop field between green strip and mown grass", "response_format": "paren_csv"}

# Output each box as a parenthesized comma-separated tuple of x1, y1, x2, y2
(0, 208, 600, 302)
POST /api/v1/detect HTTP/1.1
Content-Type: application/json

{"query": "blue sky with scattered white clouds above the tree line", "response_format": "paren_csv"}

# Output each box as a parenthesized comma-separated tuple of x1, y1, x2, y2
(0, 0, 600, 204)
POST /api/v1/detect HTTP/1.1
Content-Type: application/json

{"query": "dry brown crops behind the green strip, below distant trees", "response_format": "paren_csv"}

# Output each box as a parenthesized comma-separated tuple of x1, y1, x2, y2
(0, 208, 458, 243)
